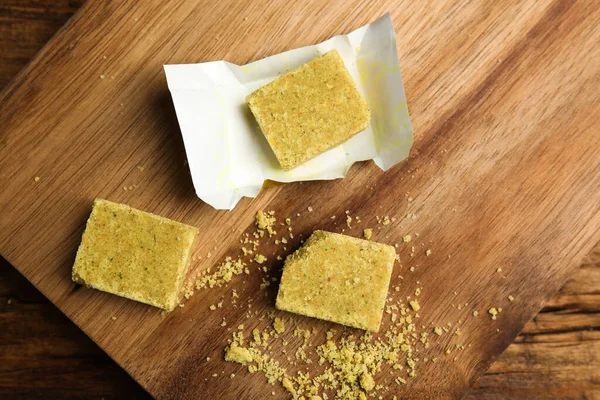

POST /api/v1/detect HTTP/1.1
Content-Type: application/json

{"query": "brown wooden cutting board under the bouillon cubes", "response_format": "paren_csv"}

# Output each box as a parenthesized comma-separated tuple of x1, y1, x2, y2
(0, 0, 600, 399)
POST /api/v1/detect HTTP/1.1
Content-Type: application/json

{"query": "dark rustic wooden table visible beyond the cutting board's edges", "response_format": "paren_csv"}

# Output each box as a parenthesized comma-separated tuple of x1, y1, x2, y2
(0, 0, 600, 399)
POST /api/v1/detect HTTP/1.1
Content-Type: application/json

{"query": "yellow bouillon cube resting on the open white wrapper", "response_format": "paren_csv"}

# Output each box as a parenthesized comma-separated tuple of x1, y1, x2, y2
(246, 50, 371, 171)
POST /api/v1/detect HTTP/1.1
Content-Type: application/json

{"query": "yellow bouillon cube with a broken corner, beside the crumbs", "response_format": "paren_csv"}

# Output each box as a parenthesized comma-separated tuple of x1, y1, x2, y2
(276, 230, 396, 332)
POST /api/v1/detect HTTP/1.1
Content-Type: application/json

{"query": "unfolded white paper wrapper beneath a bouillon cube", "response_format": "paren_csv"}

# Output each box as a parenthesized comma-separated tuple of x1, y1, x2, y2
(164, 14, 413, 210)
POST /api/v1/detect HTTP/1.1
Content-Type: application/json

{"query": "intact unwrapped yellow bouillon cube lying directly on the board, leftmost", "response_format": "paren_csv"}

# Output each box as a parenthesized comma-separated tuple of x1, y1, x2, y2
(72, 199, 198, 311)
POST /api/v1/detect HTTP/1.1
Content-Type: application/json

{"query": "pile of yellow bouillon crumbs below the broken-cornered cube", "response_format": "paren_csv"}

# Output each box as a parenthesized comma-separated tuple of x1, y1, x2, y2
(225, 297, 429, 400)
